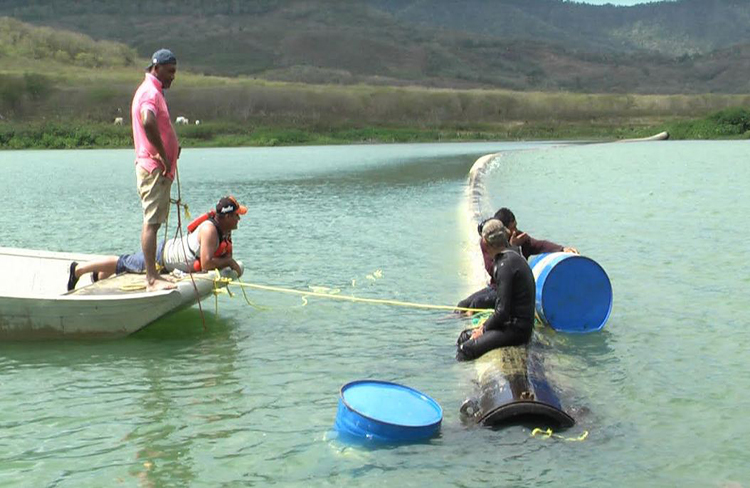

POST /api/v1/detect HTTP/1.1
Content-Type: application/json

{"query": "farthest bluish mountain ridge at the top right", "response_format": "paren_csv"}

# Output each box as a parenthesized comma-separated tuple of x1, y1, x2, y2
(368, 0, 750, 56)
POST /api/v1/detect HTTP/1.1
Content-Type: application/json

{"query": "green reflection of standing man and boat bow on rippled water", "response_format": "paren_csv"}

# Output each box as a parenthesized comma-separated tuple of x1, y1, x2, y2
(123, 309, 243, 487)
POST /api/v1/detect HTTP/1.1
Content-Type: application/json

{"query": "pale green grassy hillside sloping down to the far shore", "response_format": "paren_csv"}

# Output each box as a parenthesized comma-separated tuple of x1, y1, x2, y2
(0, 18, 750, 148)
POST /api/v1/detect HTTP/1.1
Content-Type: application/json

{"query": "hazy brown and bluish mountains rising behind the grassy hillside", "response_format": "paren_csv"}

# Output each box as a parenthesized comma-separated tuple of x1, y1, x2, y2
(0, 0, 750, 93)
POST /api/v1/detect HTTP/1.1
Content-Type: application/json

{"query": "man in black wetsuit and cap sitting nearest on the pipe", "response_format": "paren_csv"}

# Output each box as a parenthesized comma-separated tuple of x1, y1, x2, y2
(456, 219, 536, 361)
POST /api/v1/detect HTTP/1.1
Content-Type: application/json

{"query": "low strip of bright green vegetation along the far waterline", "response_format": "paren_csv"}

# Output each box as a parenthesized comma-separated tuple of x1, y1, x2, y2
(0, 108, 750, 149)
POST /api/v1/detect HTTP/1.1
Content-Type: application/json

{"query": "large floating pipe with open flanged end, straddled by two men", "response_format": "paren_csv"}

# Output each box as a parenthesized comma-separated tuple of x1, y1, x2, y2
(460, 154, 575, 427)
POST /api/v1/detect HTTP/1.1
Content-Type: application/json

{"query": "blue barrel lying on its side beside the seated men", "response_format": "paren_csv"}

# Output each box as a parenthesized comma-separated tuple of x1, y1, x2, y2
(530, 252, 612, 333)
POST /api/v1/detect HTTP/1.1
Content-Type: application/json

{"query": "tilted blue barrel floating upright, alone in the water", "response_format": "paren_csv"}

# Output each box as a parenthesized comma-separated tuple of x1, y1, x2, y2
(334, 380, 443, 443)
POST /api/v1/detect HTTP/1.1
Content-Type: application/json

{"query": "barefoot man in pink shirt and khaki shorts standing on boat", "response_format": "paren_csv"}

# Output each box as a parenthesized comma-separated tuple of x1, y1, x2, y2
(130, 49, 180, 291)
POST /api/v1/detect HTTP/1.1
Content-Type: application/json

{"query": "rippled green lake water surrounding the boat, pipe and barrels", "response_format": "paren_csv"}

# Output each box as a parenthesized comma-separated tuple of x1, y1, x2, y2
(0, 142, 750, 488)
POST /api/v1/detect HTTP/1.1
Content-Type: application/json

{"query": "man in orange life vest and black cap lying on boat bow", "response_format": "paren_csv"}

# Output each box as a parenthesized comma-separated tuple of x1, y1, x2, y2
(68, 196, 247, 291)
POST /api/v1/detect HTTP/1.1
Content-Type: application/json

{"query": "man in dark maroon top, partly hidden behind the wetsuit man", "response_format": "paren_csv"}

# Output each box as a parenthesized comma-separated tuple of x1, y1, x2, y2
(457, 207, 578, 308)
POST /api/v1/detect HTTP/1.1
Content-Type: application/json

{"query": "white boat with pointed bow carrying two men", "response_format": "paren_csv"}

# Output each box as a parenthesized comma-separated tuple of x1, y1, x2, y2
(0, 247, 231, 340)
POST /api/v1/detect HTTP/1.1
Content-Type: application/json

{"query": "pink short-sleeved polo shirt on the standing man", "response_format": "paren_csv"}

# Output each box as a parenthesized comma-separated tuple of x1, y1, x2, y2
(130, 73, 180, 180)
